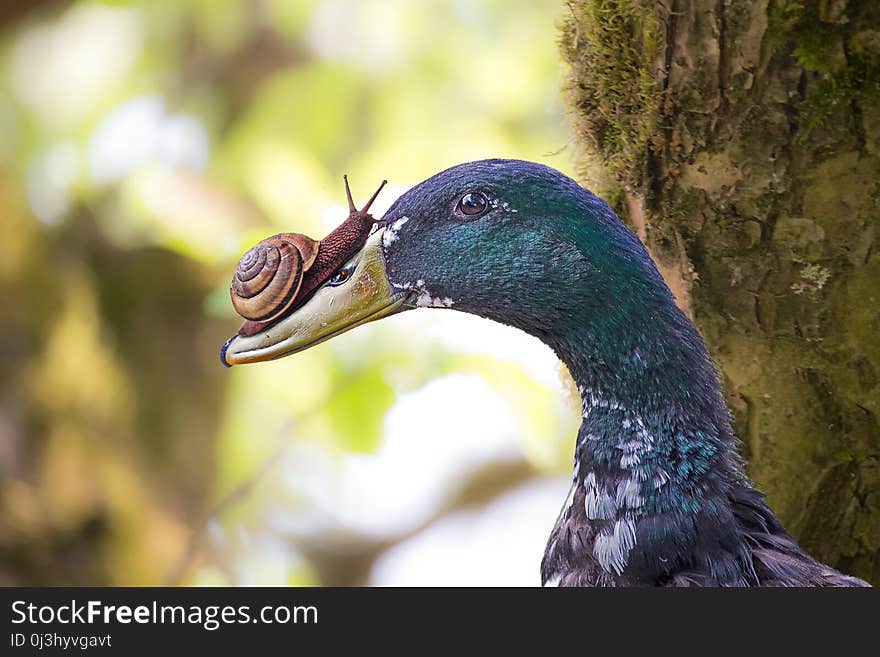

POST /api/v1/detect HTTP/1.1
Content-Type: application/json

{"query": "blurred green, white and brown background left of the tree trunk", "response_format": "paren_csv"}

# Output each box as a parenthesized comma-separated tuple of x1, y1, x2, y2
(0, 0, 578, 585)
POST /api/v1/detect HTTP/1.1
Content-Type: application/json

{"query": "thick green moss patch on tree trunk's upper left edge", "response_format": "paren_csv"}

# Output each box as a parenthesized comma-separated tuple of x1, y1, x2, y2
(560, 0, 663, 187)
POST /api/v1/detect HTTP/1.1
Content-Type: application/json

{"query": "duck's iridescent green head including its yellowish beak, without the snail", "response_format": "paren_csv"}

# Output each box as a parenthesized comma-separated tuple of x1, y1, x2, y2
(221, 159, 671, 365)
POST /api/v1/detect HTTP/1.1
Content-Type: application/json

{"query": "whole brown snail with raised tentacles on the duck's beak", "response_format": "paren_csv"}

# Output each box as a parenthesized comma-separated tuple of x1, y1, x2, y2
(229, 176, 387, 335)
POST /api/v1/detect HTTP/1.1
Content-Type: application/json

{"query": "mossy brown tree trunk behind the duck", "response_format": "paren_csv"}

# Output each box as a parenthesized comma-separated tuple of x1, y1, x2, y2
(561, 0, 880, 584)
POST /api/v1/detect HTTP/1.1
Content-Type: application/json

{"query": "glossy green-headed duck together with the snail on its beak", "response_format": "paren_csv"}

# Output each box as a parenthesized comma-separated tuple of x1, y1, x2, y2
(221, 159, 869, 587)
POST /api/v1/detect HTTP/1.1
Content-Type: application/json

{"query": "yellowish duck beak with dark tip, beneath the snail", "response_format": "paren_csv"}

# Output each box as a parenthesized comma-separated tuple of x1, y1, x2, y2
(220, 227, 406, 367)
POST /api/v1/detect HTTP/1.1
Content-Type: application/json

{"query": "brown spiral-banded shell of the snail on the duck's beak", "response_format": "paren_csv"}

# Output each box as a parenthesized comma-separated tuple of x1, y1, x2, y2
(230, 233, 319, 322)
